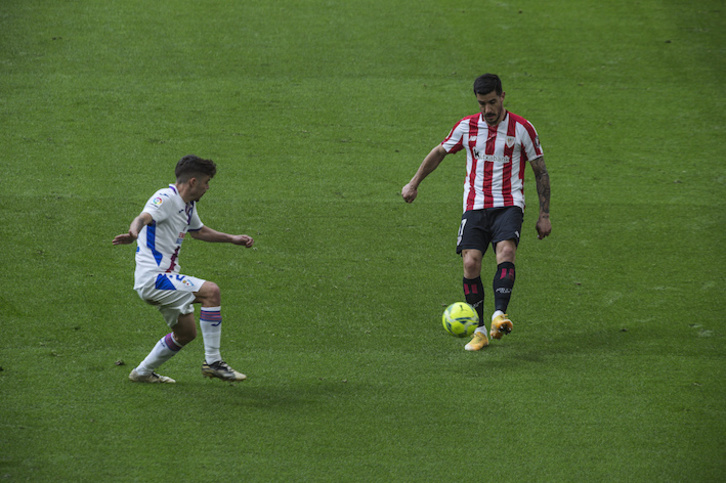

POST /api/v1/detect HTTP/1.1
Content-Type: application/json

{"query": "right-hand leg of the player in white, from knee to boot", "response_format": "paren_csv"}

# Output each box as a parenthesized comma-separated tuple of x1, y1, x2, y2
(194, 281, 247, 381)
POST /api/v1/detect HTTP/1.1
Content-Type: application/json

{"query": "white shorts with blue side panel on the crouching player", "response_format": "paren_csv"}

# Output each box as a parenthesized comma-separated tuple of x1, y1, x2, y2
(134, 273, 206, 328)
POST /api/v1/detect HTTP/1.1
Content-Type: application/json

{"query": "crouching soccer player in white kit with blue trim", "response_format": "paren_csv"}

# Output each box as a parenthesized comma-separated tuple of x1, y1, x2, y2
(113, 155, 254, 383)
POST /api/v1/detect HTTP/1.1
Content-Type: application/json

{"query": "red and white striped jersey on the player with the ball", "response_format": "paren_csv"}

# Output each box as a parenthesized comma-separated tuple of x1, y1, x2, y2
(441, 112, 542, 211)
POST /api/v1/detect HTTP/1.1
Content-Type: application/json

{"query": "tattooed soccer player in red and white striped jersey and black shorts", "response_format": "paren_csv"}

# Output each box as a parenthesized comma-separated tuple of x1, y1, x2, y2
(401, 74, 552, 351)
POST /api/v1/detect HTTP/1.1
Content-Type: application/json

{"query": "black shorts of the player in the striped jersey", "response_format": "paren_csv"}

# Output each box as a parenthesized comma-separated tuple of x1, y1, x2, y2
(456, 206, 524, 254)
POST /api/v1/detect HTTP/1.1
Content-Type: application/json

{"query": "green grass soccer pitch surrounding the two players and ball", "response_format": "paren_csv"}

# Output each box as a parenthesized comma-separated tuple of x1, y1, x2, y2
(0, 0, 726, 482)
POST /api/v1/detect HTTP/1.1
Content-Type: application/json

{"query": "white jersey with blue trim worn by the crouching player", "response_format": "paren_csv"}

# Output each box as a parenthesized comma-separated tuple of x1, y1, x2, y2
(134, 184, 204, 288)
